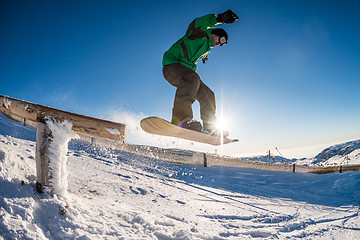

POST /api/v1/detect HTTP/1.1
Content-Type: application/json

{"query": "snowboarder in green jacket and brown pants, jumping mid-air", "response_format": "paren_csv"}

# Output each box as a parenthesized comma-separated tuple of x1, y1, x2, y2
(163, 10, 239, 136)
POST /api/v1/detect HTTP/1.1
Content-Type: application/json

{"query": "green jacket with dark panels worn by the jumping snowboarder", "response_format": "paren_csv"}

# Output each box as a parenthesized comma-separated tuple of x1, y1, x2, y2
(162, 14, 219, 71)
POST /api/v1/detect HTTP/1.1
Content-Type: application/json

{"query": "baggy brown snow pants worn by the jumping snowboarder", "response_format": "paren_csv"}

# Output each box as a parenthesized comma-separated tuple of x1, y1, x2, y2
(163, 63, 216, 125)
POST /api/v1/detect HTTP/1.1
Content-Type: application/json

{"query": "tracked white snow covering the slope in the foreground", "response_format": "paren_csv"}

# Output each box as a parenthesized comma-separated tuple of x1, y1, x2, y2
(0, 115, 360, 240)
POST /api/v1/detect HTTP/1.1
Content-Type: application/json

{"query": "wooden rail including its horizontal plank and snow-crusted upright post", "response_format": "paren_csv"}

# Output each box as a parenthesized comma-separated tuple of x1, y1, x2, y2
(0, 95, 127, 194)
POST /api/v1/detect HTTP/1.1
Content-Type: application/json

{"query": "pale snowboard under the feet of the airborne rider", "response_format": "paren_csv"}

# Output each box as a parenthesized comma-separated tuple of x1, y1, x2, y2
(140, 117, 239, 146)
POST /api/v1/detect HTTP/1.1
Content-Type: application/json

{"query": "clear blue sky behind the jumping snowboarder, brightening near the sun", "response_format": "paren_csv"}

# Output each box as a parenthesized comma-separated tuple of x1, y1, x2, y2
(0, 0, 360, 157)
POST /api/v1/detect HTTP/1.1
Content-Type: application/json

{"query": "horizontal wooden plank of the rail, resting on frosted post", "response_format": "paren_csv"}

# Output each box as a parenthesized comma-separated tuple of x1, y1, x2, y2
(0, 95, 128, 142)
